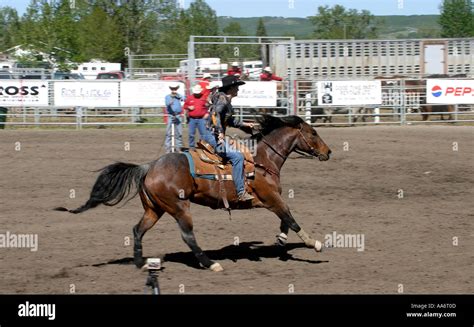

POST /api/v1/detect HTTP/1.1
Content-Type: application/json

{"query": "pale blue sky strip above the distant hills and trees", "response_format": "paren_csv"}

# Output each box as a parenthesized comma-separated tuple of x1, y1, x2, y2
(0, 0, 442, 17)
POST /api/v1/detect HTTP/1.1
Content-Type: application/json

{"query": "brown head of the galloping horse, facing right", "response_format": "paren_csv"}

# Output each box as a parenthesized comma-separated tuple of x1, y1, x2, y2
(295, 121, 331, 161)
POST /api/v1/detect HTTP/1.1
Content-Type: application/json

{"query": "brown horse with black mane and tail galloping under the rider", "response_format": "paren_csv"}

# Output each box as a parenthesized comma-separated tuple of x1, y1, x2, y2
(56, 115, 331, 271)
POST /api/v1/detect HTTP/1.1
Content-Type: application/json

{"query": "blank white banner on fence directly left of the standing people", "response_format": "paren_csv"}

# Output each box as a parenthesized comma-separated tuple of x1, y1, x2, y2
(120, 81, 186, 107)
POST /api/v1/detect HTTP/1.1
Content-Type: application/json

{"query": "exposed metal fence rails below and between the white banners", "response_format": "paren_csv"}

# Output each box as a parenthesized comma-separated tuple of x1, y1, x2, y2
(1, 79, 474, 129)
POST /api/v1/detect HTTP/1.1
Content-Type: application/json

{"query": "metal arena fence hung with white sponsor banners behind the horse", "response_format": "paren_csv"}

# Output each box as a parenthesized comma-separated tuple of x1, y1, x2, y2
(0, 79, 474, 129)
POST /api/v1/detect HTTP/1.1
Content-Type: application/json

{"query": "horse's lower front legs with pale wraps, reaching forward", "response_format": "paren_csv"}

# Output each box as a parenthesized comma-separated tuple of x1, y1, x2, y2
(268, 198, 323, 252)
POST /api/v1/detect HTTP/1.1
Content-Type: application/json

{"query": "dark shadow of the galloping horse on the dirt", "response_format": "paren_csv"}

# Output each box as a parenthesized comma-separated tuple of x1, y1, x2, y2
(92, 241, 329, 269)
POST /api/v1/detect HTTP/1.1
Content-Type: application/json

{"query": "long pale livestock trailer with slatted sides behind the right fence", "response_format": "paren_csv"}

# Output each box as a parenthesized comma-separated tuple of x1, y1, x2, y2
(269, 38, 474, 79)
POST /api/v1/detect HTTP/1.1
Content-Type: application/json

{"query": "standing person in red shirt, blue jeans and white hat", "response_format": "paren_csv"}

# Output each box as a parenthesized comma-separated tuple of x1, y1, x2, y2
(184, 84, 209, 148)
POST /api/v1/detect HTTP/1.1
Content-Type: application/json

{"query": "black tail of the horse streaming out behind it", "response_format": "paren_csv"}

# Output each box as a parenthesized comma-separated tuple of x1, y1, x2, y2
(54, 162, 150, 213)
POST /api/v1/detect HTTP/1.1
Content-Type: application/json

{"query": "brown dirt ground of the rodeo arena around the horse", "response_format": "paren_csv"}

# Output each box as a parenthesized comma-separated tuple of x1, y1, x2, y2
(0, 126, 474, 294)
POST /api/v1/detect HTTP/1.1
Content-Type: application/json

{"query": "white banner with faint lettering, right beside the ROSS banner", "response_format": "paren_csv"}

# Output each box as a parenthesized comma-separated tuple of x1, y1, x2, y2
(54, 81, 119, 107)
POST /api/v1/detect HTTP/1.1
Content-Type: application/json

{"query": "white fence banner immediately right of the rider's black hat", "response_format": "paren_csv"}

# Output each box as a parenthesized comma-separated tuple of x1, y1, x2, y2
(232, 82, 277, 107)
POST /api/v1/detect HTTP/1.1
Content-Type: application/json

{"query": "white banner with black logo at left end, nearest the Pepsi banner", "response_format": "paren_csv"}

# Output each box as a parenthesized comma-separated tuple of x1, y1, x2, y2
(318, 81, 382, 106)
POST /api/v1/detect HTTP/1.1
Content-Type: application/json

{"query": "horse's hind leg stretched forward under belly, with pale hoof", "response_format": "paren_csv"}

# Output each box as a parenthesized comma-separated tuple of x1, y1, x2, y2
(172, 201, 224, 271)
